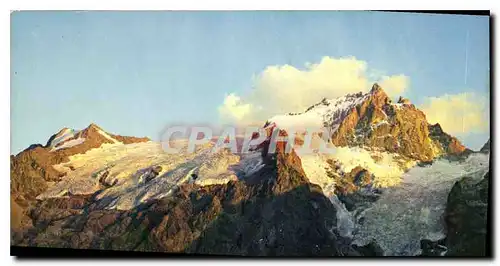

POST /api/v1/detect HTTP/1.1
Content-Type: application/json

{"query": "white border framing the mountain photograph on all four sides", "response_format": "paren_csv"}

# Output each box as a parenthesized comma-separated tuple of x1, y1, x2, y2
(0, 0, 500, 265)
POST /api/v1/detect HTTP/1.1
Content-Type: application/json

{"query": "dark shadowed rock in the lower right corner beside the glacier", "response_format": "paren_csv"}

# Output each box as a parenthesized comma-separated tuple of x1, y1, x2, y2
(445, 172, 491, 256)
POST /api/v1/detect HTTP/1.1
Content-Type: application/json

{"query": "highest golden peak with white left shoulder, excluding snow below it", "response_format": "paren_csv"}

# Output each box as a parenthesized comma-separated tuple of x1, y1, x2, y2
(269, 83, 466, 161)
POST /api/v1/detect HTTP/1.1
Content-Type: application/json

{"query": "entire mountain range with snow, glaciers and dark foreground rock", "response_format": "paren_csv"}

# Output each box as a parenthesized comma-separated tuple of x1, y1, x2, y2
(10, 84, 490, 257)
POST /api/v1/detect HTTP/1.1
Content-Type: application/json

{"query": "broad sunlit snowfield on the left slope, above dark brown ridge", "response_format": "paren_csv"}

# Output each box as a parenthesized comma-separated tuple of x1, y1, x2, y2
(37, 141, 262, 210)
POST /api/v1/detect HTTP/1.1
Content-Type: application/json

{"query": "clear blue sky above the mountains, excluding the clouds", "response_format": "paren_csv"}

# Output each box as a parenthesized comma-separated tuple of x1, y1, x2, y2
(11, 11, 489, 153)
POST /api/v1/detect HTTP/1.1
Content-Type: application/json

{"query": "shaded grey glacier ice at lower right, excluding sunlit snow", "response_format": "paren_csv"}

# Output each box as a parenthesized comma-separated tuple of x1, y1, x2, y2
(352, 154, 489, 256)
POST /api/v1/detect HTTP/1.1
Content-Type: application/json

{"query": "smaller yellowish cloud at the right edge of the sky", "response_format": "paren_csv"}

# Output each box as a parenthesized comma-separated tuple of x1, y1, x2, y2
(420, 92, 489, 135)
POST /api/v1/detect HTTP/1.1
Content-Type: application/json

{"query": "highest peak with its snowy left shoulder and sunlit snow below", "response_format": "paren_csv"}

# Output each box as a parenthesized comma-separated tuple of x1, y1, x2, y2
(264, 83, 471, 197)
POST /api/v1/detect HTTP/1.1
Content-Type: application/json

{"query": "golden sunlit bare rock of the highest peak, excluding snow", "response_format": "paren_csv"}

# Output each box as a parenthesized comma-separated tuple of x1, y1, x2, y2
(332, 84, 465, 161)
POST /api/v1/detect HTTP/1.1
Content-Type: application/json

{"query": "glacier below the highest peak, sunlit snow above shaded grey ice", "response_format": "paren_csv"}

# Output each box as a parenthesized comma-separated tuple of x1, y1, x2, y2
(294, 148, 489, 256)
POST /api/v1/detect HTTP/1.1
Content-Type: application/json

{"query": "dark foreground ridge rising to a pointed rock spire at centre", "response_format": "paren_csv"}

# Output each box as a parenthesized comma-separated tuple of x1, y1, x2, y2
(11, 142, 383, 256)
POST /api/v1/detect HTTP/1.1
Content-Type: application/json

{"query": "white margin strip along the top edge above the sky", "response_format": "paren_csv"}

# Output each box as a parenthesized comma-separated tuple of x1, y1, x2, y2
(0, 0, 495, 10)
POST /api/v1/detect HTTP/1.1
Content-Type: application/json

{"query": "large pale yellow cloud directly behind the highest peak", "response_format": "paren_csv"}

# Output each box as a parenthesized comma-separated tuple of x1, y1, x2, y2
(219, 56, 408, 123)
